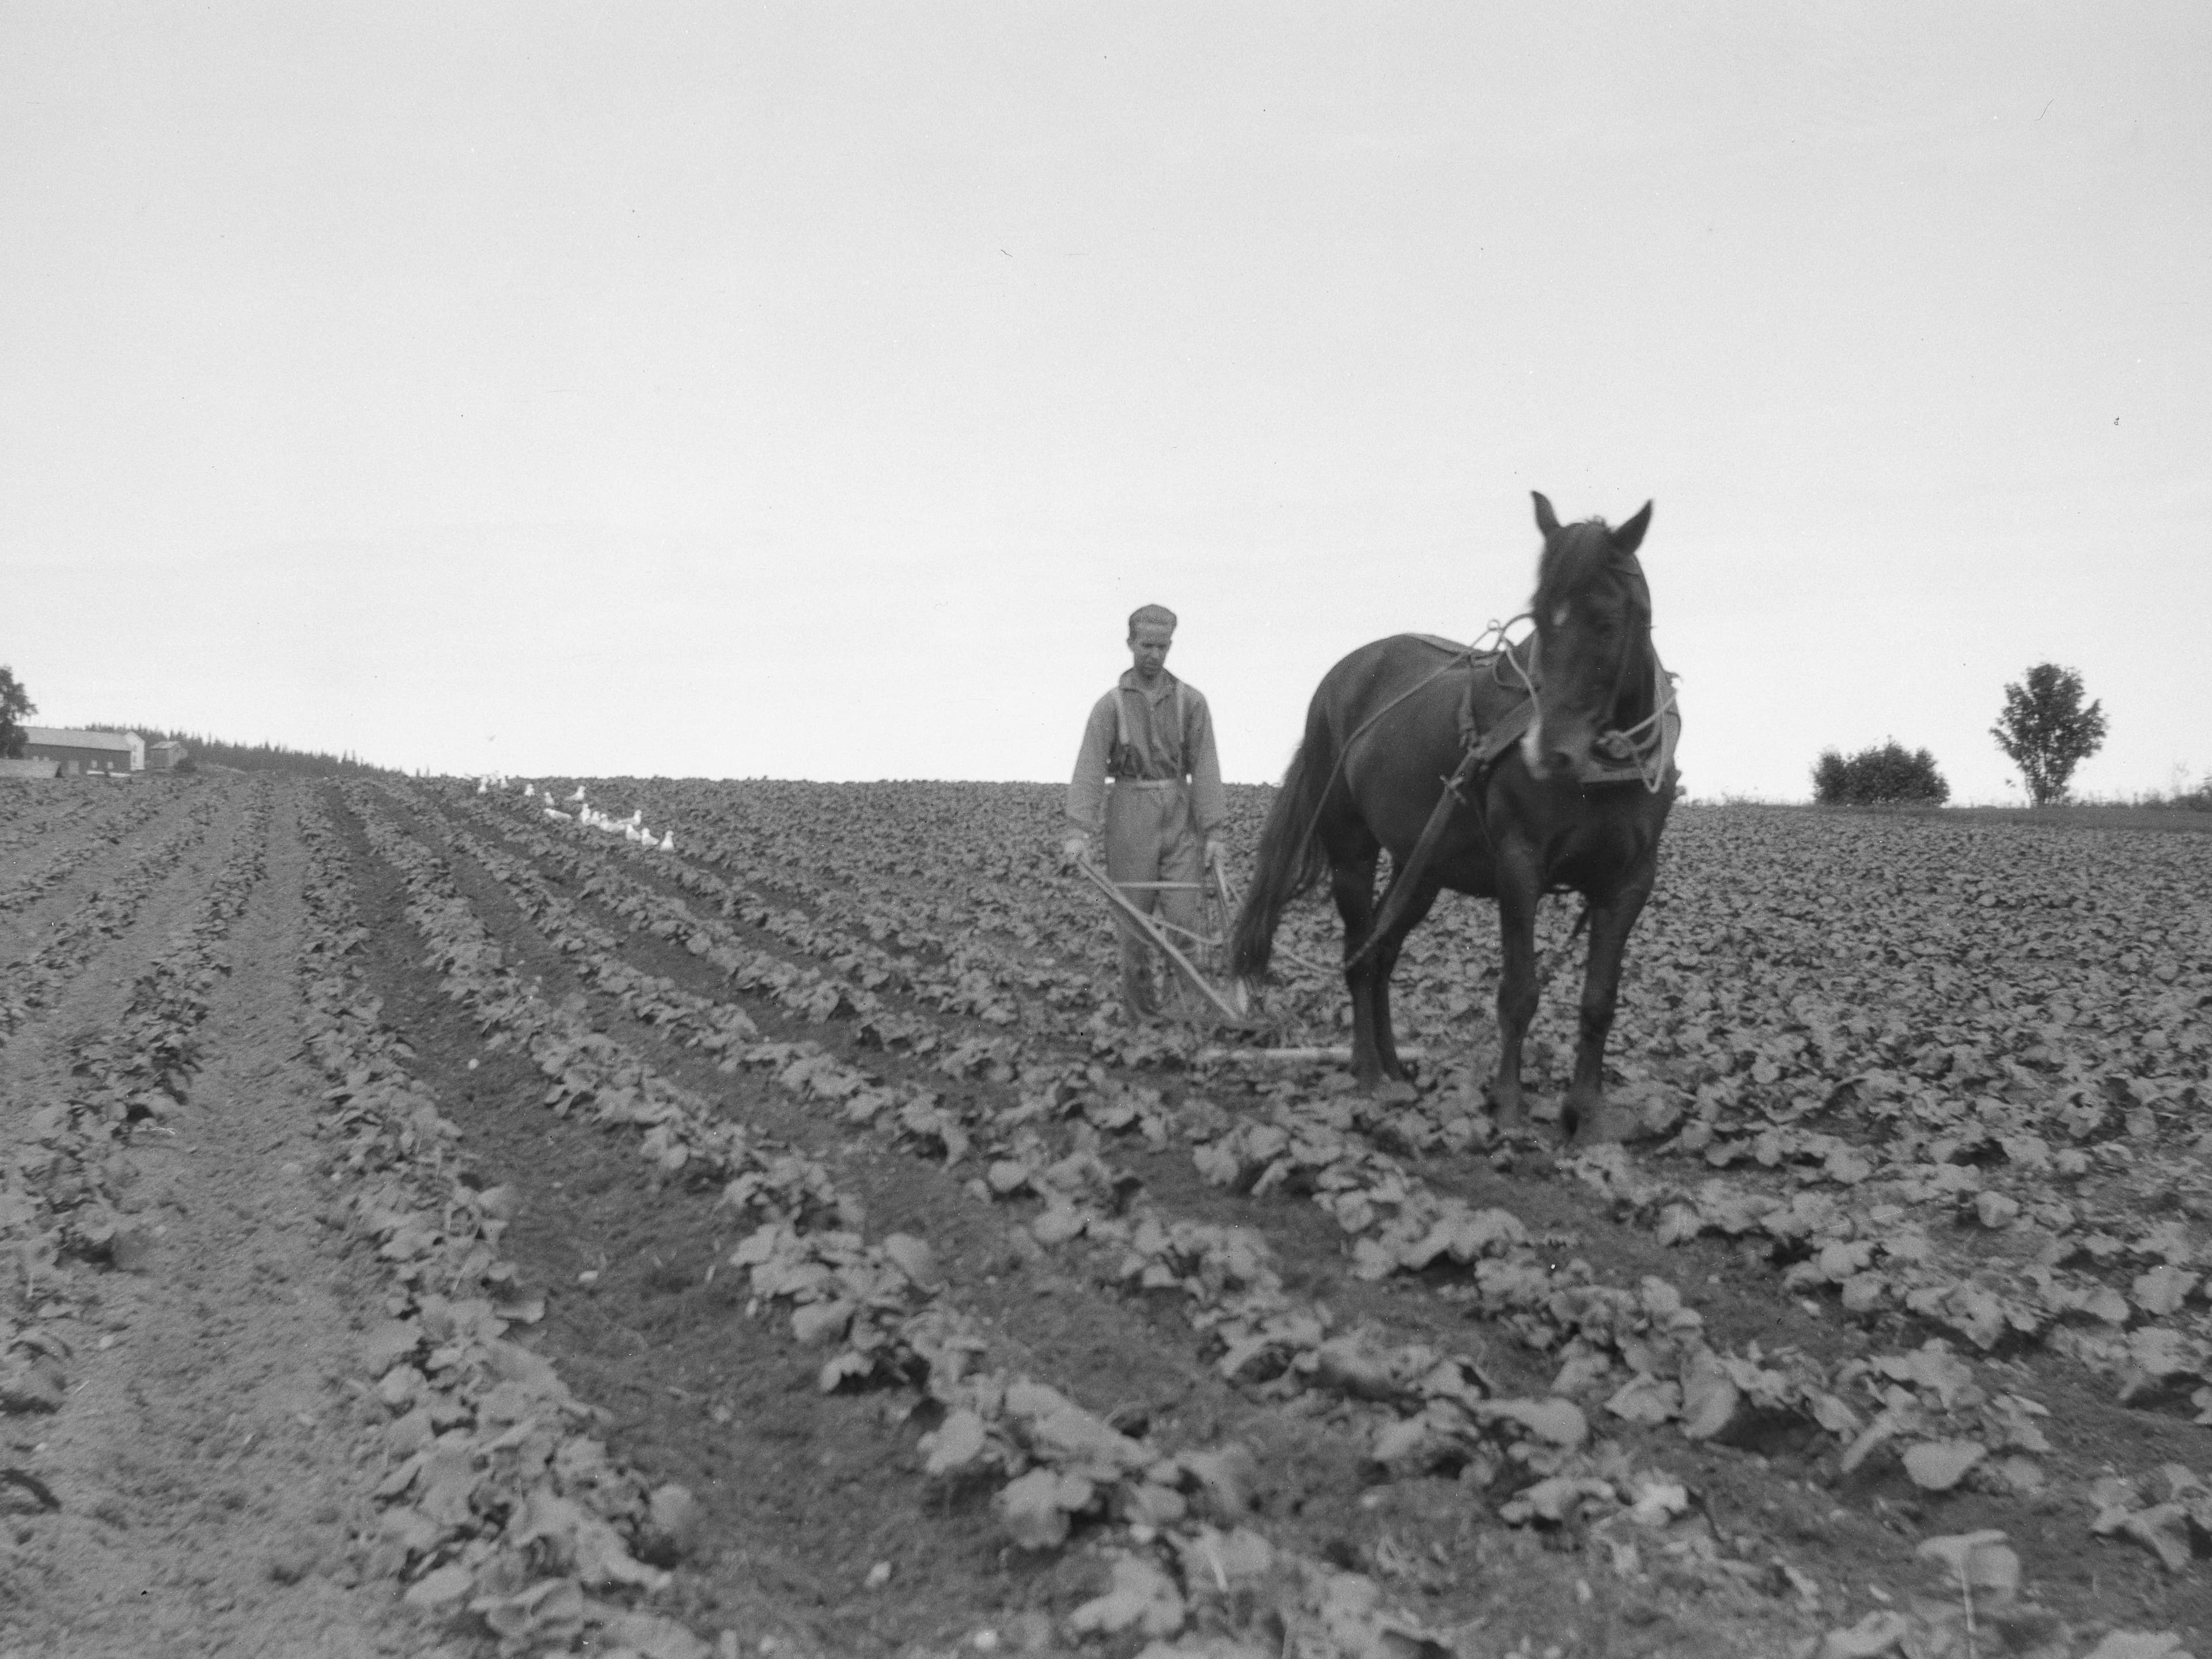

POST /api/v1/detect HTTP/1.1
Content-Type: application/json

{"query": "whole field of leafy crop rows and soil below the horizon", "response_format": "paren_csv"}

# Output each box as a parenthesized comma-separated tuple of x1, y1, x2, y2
(0, 779, 2212, 1659)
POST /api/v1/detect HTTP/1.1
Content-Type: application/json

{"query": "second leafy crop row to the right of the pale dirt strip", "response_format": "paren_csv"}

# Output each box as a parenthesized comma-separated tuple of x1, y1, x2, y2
(350, 790, 1460, 1635)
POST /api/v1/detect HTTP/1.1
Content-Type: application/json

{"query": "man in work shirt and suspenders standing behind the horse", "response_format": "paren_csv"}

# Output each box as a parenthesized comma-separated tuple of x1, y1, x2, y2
(1066, 604, 1228, 1020)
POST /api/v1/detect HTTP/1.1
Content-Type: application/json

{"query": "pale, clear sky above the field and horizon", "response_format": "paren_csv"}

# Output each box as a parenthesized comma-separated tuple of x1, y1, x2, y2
(0, 0, 2212, 801)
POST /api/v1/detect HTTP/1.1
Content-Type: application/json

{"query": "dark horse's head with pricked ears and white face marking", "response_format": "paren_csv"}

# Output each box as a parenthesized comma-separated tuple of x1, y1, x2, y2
(1522, 495, 1652, 779)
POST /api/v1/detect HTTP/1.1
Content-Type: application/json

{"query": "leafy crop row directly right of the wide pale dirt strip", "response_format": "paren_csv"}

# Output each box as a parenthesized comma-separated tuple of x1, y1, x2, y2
(297, 787, 734, 1659)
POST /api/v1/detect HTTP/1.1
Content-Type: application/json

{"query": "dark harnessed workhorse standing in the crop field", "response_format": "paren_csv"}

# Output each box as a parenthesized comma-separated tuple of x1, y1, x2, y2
(1230, 493, 1681, 1143)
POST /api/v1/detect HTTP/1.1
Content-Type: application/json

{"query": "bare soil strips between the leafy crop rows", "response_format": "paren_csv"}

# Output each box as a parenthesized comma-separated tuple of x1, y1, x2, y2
(0, 777, 2212, 1659)
